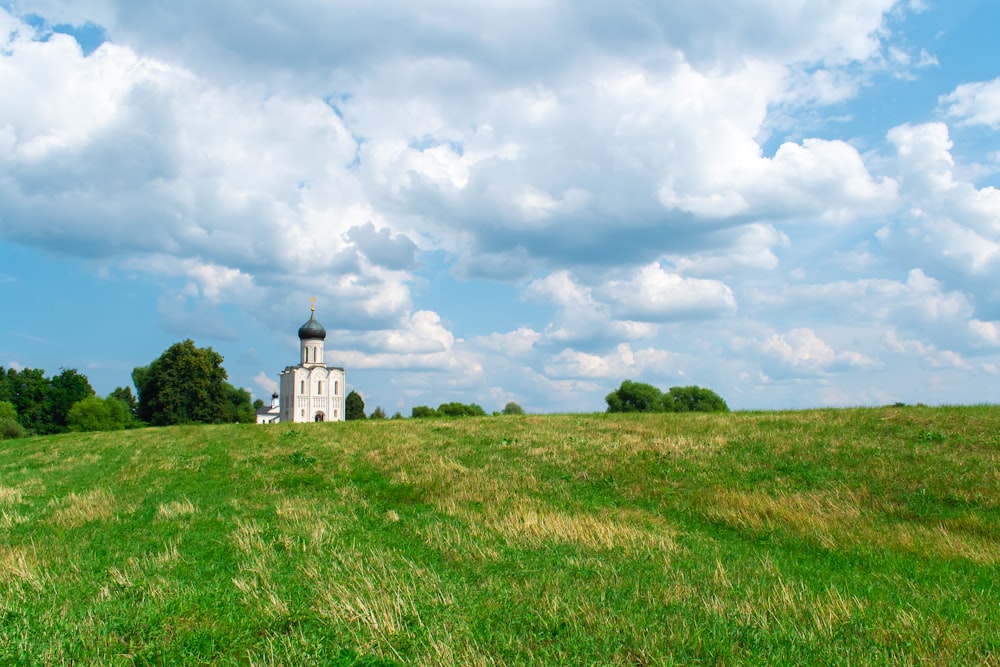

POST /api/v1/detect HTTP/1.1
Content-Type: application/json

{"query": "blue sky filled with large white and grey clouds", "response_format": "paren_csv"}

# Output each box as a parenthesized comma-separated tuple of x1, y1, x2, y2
(0, 0, 1000, 416)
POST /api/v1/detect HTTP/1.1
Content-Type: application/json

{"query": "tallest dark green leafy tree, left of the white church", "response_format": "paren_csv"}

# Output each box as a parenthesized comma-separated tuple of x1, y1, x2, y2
(132, 339, 234, 426)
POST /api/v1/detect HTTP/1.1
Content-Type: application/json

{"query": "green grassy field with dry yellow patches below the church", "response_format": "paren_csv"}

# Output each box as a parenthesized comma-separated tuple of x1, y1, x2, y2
(0, 407, 1000, 666)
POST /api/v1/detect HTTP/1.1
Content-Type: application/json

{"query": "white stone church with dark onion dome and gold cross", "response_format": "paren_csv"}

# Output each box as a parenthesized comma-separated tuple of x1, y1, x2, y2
(257, 299, 347, 424)
